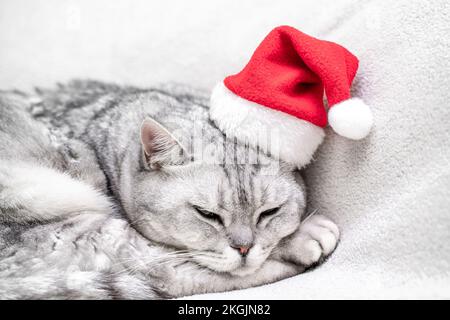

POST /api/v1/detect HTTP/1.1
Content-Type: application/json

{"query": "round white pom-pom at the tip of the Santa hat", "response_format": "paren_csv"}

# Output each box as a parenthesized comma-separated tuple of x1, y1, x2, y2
(328, 98, 373, 140)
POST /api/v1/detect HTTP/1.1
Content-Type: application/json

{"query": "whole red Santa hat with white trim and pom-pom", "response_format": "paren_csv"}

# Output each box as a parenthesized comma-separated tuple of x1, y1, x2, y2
(210, 26, 373, 167)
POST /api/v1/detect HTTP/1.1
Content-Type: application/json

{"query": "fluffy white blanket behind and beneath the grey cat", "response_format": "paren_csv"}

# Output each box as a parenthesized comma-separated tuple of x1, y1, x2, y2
(0, 0, 450, 299)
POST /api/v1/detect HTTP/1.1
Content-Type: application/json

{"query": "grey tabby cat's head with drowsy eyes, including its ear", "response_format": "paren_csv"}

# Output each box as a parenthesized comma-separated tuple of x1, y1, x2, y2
(127, 119, 306, 276)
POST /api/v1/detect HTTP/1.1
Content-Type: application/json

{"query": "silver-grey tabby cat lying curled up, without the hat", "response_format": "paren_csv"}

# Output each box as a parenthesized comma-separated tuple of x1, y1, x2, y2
(0, 81, 339, 299)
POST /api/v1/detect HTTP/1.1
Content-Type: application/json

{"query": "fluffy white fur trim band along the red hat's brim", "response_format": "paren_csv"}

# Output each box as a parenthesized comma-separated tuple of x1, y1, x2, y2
(210, 82, 325, 168)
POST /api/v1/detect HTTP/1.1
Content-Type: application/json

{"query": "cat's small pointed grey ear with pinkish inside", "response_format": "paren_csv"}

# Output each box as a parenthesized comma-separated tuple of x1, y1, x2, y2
(141, 118, 186, 169)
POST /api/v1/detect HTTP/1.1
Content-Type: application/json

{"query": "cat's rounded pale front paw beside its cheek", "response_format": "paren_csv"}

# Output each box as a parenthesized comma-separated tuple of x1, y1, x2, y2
(286, 215, 339, 267)
